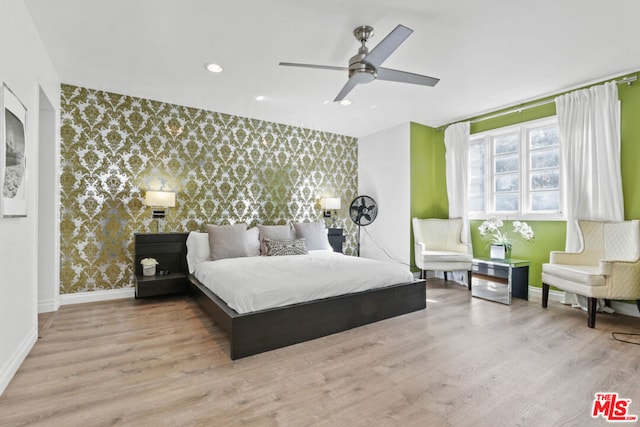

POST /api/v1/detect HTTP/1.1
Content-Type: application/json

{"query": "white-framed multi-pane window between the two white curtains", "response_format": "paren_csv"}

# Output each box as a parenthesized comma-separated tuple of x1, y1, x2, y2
(469, 117, 562, 218)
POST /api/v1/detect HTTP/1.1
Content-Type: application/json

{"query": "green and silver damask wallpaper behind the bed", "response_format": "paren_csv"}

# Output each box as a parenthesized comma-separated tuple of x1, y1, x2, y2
(60, 85, 358, 293)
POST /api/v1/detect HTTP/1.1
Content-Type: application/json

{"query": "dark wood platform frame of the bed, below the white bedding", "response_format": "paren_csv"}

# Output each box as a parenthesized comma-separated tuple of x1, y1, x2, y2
(188, 275, 427, 360)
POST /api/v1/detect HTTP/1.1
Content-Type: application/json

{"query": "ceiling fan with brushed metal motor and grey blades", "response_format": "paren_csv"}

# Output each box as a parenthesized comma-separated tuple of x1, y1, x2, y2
(279, 25, 440, 102)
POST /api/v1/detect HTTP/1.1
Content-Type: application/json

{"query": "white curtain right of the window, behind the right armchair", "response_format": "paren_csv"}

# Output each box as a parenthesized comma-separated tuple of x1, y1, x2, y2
(556, 82, 624, 311)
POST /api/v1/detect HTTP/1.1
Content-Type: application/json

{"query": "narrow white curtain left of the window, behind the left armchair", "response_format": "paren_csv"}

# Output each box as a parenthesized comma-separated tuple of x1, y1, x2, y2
(444, 122, 471, 283)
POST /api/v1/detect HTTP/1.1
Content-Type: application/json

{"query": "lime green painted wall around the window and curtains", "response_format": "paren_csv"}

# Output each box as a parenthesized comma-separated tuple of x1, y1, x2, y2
(411, 72, 640, 287)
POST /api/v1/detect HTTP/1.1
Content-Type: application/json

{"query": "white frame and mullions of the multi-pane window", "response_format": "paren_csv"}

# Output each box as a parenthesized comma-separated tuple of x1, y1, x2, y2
(467, 116, 566, 221)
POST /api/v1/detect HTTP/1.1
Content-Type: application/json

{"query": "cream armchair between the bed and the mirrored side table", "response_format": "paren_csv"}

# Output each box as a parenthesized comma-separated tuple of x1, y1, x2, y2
(412, 218, 473, 290)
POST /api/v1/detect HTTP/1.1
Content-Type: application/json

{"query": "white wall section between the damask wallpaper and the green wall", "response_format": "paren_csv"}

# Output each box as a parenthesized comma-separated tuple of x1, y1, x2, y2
(358, 123, 411, 264)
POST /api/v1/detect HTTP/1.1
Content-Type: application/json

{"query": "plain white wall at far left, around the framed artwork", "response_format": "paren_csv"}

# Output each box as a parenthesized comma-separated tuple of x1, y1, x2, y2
(0, 0, 60, 393)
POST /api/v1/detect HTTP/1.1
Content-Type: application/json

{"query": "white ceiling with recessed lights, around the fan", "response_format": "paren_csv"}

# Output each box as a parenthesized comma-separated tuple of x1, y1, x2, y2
(25, 0, 640, 137)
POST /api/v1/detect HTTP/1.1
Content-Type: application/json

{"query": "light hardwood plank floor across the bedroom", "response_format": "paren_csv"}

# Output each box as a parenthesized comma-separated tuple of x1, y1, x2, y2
(0, 279, 640, 426)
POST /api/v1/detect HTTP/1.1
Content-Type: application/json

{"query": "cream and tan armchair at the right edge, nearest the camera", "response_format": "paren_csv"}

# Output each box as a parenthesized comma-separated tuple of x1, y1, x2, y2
(542, 220, 640, 328)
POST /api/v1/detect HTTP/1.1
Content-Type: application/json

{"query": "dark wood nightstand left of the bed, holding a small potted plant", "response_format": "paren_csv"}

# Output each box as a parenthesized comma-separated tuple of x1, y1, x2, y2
(134, 233, 188, 298)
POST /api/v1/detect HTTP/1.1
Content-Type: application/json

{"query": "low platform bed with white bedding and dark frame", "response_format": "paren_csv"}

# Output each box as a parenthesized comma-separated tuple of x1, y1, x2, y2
(187, 227, 426, 360)
